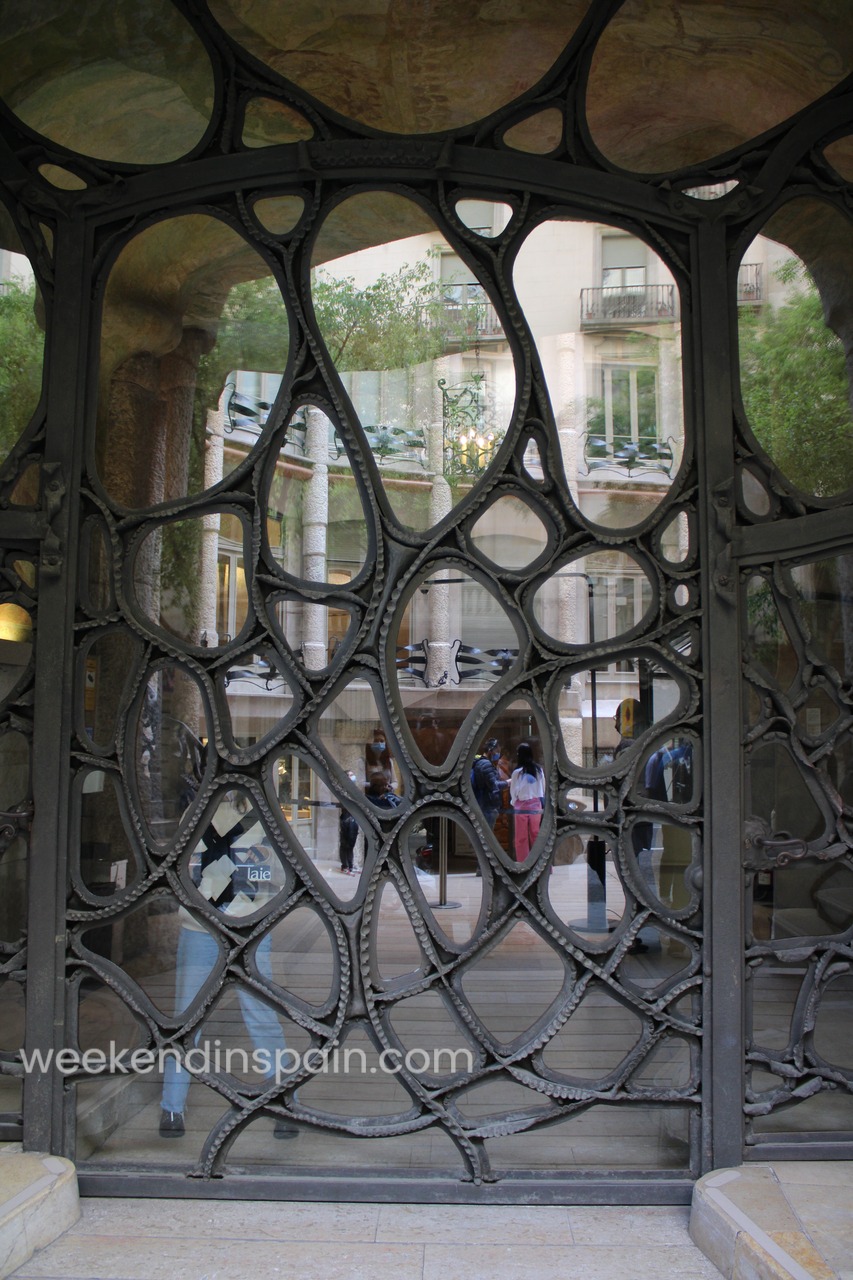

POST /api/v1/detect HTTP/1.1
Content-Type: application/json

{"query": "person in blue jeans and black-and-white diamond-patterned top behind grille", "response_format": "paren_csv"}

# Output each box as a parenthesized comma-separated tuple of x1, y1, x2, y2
(160, 792, 298, 1138)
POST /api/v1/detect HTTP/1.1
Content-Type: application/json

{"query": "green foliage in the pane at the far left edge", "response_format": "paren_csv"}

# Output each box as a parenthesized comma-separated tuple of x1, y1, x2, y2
(0, 282, 45, 461)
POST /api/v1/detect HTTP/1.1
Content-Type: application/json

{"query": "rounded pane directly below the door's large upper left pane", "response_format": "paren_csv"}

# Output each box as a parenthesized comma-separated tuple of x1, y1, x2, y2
(133, 508, 250, 649)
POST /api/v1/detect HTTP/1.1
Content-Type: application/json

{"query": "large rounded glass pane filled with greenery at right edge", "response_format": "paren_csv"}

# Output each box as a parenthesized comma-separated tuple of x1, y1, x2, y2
(738, 200, 853, 497)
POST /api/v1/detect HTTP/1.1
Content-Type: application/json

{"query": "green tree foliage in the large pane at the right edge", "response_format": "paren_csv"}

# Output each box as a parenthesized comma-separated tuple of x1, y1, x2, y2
(739, 260, 853, 495)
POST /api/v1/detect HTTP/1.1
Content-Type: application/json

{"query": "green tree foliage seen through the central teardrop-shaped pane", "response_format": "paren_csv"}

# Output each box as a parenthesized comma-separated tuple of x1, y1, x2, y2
(311, 260, 444, 372)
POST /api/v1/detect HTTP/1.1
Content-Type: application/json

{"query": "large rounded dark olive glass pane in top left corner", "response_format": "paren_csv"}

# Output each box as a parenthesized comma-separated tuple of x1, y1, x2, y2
(4, 0, 214, 164)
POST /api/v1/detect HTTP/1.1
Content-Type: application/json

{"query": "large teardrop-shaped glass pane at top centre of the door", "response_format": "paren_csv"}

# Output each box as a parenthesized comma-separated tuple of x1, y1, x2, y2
(313, 193, 515, 530)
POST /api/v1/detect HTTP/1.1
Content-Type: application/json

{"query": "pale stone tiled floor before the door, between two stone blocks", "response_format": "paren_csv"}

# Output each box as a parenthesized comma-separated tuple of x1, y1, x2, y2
(13, 1199, 720, 1280)
